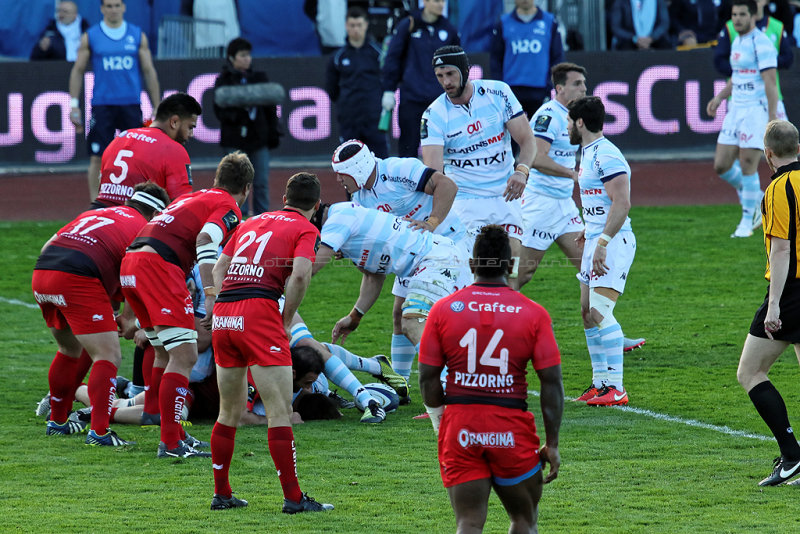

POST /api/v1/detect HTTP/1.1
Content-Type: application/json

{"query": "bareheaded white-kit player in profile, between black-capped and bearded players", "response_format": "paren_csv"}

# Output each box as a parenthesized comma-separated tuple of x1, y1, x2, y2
(519, 63, 646, 352)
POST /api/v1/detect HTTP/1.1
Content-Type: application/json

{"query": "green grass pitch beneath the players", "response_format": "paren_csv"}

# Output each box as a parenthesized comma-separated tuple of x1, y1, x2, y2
(0, 206, 800, 534)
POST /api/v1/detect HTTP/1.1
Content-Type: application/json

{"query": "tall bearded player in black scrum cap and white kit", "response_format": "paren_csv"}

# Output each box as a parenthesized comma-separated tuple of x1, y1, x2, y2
(420, 46, 536, 289)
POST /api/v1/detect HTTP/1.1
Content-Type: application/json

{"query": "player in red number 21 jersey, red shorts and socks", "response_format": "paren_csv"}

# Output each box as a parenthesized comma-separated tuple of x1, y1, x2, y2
(211, 172, 333, 514)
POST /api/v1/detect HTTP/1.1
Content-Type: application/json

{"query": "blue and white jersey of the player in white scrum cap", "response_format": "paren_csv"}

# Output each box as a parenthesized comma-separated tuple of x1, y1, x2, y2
(351, 158, 467, 246)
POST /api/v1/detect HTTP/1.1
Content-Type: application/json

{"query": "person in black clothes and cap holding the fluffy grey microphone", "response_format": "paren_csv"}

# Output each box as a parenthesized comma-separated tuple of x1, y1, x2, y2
(214, 37, 280, 215)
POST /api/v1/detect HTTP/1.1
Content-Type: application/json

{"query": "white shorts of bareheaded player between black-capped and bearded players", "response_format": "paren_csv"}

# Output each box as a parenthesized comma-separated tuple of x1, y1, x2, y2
(522, 191, 583, 250)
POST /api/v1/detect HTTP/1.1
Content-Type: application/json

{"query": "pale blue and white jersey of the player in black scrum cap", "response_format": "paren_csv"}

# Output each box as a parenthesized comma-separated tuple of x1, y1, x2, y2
(420, 80, 523, 198)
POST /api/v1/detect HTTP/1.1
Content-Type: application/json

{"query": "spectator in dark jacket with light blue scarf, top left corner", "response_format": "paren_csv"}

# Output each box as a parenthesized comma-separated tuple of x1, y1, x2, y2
(31, 0, 89, 61)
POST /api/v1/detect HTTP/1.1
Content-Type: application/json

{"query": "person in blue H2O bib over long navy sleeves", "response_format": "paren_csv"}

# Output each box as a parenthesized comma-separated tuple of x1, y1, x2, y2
(490, 0, 564, 119)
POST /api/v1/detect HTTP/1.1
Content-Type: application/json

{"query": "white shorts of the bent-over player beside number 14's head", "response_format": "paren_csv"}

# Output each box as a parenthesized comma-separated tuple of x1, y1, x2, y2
(403, 237, 472, 317)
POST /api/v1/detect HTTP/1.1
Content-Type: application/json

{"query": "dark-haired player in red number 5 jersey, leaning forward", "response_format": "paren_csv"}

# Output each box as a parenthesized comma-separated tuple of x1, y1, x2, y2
(92, 93, 203, 208)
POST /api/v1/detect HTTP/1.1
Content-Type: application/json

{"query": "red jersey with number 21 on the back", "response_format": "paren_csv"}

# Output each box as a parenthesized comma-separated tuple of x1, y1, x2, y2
(217, 209, 319, 302)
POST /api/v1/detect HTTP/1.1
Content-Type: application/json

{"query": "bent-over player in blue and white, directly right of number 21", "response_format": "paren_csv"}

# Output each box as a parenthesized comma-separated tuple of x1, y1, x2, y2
(313, 202, 472, 374)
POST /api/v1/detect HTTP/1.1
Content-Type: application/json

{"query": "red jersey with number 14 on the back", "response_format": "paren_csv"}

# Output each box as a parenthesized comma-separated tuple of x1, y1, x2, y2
(419, 284, 561, 409)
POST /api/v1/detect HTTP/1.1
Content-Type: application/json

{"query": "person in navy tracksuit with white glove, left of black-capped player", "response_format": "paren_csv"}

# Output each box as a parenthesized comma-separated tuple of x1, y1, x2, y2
(382, 0, 461, 158)
